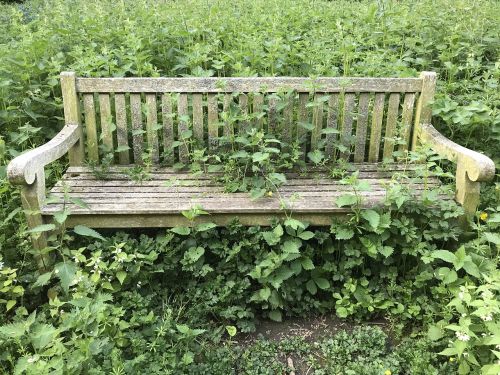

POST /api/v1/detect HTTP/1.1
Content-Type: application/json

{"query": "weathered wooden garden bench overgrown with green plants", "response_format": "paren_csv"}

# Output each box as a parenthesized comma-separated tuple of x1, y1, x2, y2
(8, 72, 495, 253)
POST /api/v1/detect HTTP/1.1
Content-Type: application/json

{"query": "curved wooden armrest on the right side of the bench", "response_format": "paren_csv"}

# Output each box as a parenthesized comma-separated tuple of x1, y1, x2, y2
(420, 124, 495, 182)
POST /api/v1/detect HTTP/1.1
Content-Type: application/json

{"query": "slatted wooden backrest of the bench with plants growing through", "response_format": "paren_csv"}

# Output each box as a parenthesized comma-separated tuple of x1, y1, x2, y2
(61, 72, 436, 165)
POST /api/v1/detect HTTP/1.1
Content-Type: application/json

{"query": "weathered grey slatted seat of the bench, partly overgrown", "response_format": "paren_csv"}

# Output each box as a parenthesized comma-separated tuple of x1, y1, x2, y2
(41, 163, 451, 228)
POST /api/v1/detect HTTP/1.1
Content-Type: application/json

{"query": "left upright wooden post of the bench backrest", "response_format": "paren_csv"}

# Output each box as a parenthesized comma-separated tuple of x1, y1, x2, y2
(61, 72, 85, 165)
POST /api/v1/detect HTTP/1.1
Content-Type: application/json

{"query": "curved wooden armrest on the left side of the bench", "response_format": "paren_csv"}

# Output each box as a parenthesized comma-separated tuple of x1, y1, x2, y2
(7, 124, 79, 185)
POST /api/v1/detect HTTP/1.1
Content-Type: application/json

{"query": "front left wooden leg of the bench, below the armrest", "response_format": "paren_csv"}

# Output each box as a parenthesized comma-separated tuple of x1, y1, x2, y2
(21, 170, 52, 272)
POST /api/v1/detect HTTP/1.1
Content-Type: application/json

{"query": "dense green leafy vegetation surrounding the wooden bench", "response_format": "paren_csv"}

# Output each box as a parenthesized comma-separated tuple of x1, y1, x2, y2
(0, 0, 500, 375)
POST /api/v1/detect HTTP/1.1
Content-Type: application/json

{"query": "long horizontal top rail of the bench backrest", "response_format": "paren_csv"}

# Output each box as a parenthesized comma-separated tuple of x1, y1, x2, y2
(76, 77, 422, 93)
